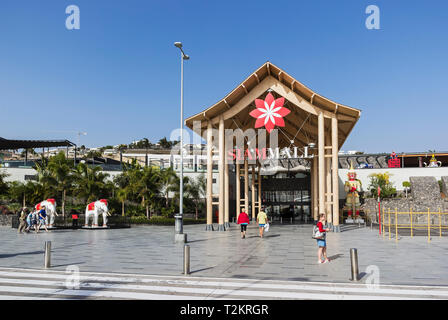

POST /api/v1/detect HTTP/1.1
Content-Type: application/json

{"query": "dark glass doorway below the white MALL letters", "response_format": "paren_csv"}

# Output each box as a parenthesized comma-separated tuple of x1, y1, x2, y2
(261, 172, 313, 223)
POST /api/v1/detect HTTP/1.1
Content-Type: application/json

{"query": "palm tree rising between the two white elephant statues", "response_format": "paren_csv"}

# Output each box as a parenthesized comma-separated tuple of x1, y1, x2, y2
(48, 151, 73, 217)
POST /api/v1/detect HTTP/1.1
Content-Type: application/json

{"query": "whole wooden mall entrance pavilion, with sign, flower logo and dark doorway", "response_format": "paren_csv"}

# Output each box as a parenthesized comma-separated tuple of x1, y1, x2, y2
(185, 61, 361, 231)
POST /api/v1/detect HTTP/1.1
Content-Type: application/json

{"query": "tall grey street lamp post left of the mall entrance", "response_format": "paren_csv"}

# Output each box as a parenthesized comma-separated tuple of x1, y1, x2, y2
(174, 42, 190, 242)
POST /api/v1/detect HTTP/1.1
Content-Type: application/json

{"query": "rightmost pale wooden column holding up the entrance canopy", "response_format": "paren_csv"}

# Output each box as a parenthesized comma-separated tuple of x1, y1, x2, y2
(331, 118, 339, 231)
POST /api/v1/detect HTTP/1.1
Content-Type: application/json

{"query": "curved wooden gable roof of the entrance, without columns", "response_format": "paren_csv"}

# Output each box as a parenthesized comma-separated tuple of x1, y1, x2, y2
(185, 62, 361, 148)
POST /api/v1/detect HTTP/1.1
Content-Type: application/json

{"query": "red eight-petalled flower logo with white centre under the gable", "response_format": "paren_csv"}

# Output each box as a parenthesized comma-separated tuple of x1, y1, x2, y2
(250, 93, 291, 133)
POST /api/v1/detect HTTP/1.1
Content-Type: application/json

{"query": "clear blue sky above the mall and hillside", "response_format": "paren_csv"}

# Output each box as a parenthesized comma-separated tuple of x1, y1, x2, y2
(0, 0, 448, 152)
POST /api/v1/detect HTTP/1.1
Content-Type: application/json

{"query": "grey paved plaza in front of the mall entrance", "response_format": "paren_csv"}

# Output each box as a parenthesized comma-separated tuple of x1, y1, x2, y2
(0, 224, 448, 285)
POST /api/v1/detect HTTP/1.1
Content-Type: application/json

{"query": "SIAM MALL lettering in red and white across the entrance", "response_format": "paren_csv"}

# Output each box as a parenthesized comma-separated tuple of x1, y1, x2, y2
(227, 147, 314, 161)
